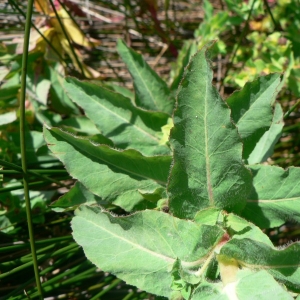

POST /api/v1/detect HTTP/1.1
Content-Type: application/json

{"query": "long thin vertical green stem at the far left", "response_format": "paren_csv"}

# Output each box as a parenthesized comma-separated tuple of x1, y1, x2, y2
(20, 0, 43, 299)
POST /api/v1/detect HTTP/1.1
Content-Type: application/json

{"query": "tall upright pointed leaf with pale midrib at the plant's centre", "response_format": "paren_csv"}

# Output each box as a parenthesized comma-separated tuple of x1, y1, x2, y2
(168, 49, 252, 218)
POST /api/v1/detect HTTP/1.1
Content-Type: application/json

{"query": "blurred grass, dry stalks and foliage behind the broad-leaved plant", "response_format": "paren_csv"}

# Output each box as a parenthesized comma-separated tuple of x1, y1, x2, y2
(0, 0, 300, 300)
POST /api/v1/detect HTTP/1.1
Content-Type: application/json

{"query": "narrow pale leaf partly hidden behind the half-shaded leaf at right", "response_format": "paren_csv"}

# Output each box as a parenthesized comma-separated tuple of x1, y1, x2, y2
(248, 103, 284, 165)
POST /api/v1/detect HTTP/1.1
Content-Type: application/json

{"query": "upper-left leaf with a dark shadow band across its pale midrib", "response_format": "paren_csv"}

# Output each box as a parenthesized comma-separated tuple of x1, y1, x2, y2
(64, 78, 170, 155)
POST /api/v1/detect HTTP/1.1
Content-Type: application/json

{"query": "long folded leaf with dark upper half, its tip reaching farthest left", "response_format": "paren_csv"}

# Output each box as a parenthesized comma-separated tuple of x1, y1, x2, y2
(44, 128, 171, 211)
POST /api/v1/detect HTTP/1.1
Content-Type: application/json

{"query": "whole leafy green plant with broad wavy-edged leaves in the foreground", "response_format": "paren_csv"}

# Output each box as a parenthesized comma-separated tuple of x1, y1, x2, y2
(44, 41, 300, 300)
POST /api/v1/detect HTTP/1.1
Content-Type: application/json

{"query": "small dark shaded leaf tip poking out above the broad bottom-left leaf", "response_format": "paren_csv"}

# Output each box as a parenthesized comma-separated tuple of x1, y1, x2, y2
(50, 181, 107, 212)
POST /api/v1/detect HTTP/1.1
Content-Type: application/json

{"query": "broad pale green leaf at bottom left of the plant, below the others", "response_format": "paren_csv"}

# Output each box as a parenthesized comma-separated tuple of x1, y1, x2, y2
(72, 206, 224, 297)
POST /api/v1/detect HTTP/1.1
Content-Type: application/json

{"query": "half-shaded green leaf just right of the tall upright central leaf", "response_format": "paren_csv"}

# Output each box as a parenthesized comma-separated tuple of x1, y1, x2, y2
(227, 74, 282, 159)
